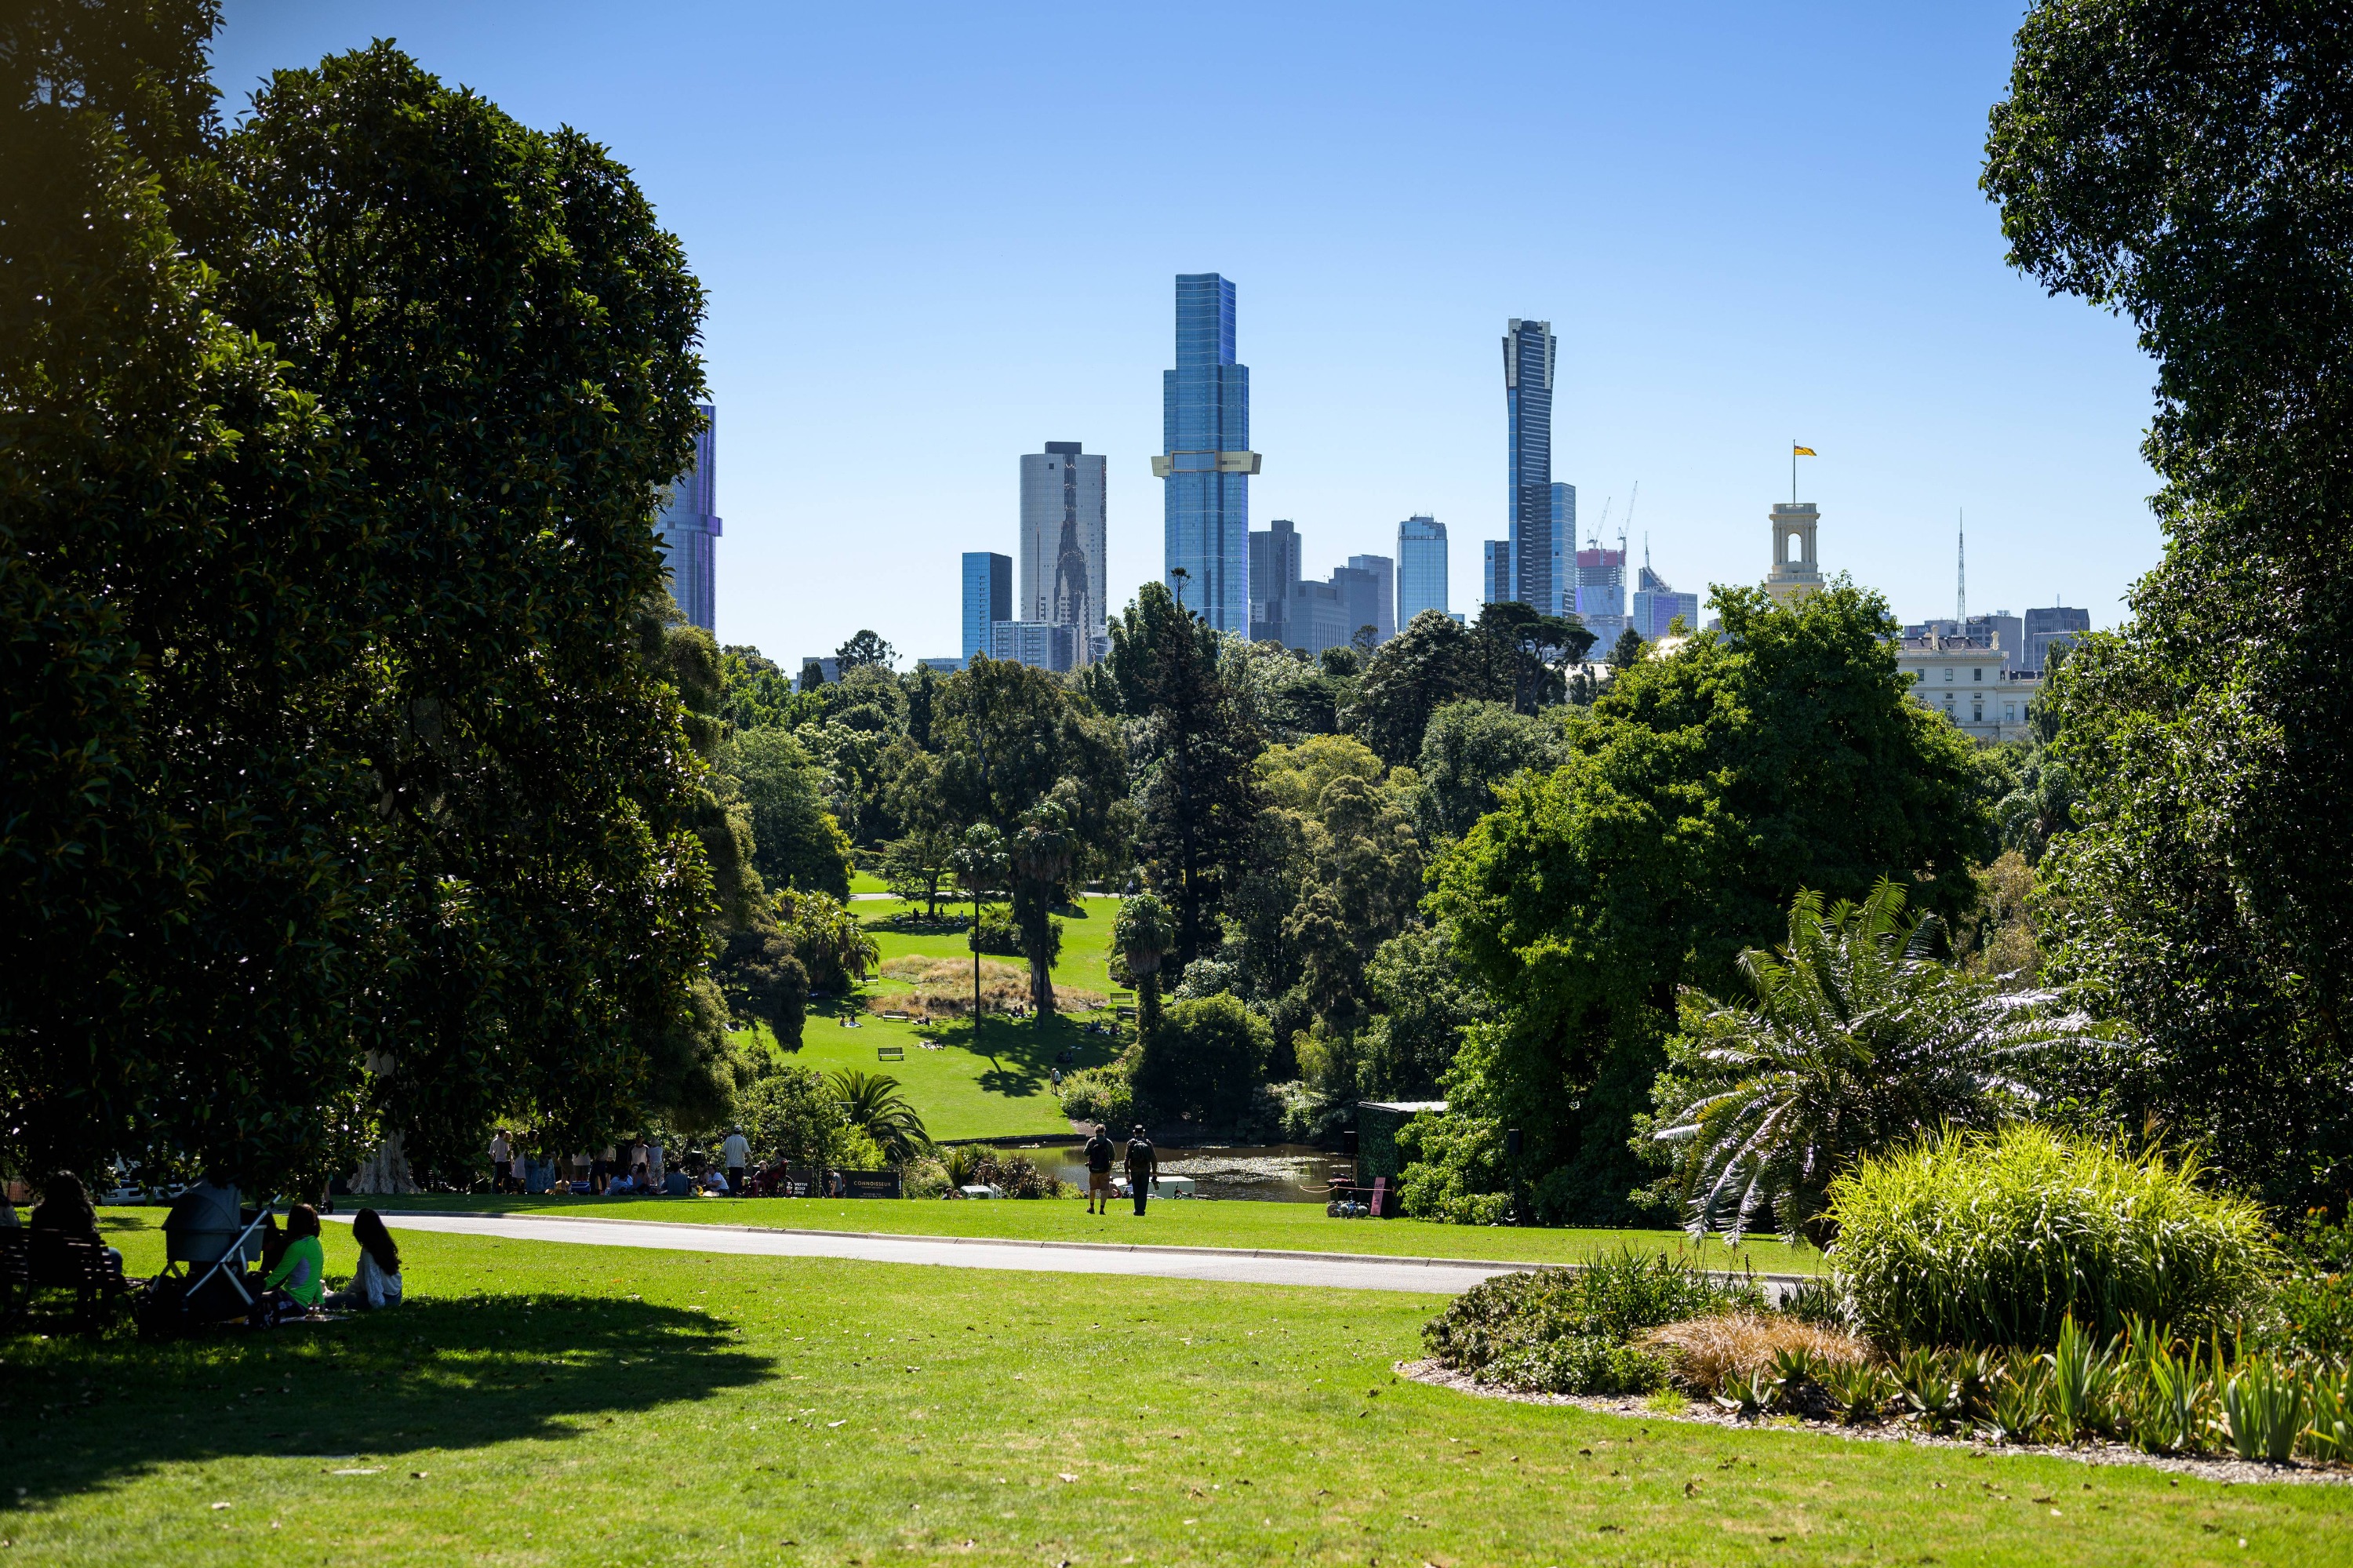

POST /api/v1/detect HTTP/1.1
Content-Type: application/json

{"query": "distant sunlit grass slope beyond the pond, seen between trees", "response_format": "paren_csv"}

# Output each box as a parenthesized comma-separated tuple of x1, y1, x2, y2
(744, 897, 1118, 1140)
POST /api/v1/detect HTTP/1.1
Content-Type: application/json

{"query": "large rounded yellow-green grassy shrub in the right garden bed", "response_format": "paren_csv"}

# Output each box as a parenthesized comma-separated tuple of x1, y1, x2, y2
(1828, 1123, 2275, 1347)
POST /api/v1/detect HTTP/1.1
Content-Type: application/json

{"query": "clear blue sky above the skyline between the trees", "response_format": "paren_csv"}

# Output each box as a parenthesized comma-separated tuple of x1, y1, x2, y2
(214, 0, 2160, 666)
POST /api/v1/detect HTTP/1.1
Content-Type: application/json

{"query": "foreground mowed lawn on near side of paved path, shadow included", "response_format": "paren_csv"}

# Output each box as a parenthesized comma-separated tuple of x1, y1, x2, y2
(0, 1215, 2353, 1568)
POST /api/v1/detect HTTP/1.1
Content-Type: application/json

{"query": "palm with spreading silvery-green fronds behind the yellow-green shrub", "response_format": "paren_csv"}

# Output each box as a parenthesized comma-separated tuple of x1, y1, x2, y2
(1652, 879, 2111, 1246)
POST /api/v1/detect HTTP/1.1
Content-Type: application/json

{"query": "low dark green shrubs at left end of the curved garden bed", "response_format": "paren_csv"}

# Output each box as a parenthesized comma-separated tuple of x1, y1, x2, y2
(1421, 1248, 1762, 1394)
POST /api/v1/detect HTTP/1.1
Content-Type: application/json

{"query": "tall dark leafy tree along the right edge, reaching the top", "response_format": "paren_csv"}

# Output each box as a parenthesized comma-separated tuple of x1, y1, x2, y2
(1984, 0, 2353, 1203)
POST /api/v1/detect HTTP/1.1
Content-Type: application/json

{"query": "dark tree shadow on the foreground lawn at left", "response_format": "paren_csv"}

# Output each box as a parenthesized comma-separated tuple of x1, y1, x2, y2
(0, 1295, 774, 1507)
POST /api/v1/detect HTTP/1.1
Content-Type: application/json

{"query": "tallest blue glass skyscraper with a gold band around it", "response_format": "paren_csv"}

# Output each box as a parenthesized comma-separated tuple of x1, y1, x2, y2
(1153, 273, 1259, 635)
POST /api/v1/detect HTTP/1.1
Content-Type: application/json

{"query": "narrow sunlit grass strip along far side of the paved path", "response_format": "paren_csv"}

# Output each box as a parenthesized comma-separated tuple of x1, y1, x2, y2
(344, 1194, 1821, 1274)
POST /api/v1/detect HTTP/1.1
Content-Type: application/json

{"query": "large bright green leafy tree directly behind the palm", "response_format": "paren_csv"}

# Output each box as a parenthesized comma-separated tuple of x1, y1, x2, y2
(1433, 581, 1988, 1217)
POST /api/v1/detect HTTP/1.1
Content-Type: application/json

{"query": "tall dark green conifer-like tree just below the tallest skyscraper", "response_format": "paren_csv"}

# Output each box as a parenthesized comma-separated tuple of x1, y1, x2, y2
(1104, 581, 1264, 966)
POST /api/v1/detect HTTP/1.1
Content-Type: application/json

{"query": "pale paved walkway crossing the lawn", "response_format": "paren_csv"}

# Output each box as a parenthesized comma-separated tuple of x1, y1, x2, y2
(334, 1215, 1534, 1295)
